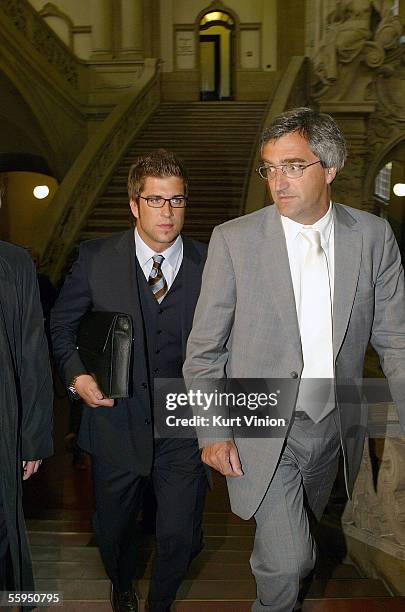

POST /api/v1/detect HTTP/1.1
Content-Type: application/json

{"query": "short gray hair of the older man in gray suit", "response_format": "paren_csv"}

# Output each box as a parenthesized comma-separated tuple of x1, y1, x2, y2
(261, 106, 347, 172)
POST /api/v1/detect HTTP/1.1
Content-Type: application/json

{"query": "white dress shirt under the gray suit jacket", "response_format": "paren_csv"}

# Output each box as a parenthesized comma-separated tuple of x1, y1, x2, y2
(281, 202, 335, 320)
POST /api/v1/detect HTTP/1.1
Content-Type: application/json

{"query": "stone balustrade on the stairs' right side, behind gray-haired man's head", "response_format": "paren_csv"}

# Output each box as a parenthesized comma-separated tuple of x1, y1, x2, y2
(243, 56, 309, 214)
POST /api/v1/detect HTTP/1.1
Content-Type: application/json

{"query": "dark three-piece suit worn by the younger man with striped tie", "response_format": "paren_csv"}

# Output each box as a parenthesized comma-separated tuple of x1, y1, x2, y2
(51, 230, 206, 610)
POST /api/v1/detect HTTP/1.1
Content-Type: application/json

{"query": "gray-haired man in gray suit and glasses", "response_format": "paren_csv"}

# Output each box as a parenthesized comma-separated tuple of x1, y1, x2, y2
(184, 108, 405, 612)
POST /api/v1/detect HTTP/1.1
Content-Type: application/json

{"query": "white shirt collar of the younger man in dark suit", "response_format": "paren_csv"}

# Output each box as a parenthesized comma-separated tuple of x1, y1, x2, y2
(135, 228, 183, 290)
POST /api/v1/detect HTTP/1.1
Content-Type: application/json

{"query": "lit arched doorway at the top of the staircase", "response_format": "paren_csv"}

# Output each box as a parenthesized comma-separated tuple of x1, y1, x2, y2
(199, 11, 235, 100)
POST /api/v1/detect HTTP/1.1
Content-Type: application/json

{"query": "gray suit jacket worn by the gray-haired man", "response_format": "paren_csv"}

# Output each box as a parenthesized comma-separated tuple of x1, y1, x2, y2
(184, 204, 405, 518)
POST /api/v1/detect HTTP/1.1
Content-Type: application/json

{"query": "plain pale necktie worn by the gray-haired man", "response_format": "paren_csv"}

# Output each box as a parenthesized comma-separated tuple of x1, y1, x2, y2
(296, 228, 335, 422)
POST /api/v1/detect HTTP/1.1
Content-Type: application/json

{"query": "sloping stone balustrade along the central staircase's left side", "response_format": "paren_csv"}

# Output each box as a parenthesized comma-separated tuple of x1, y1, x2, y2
(34, 58, 160, 280)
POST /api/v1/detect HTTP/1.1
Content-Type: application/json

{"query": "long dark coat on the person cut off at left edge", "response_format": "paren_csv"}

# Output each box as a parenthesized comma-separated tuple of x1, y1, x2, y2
(0, 241, 53, 591)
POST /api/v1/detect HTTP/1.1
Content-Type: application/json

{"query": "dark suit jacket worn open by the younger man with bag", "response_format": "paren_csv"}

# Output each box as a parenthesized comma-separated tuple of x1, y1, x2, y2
(51, 229, 207, 474)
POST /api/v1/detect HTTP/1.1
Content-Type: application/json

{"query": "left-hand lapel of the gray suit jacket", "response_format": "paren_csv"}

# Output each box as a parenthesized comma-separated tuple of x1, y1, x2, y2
(255, 205, 302, 354)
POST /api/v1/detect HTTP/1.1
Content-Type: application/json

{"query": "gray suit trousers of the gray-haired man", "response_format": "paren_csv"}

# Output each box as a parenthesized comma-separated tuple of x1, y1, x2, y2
(250, 412, 340, 612)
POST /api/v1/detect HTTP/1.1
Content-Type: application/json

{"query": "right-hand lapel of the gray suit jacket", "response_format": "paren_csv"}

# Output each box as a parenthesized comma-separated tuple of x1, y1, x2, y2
(333, 204, 362, 359)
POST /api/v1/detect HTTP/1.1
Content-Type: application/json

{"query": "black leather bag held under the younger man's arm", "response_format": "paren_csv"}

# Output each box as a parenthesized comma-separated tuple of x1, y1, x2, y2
(77, 311, 133, 399)
